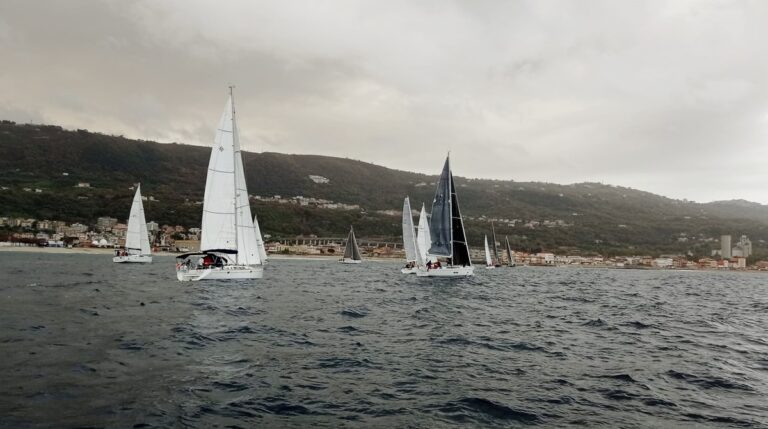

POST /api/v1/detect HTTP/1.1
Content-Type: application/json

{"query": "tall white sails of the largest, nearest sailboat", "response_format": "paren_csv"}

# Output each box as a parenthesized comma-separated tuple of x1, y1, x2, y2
(200, 92, 261, 265)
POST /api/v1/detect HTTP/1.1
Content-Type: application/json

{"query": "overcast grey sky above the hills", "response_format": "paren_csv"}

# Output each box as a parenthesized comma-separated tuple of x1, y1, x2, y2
(0, 0, 768, 204)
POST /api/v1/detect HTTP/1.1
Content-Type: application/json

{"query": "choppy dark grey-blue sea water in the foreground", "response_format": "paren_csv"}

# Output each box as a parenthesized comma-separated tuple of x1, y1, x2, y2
(0, 252, 768, 428)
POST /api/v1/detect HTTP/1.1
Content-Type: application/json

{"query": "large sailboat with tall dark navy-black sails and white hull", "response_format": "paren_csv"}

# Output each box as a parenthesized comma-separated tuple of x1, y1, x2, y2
(416, 155, 474, 277)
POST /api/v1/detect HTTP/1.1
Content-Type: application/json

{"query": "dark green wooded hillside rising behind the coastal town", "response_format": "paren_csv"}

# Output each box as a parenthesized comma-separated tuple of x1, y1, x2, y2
(0, 121, 768, 255)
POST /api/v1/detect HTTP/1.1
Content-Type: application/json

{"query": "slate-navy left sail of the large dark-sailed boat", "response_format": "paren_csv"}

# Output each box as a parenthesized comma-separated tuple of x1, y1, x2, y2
(427, 158, 452, 257)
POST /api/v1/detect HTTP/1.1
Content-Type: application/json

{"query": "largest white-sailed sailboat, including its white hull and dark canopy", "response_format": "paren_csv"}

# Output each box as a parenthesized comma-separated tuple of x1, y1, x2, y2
(176, 87, 264, 281)
